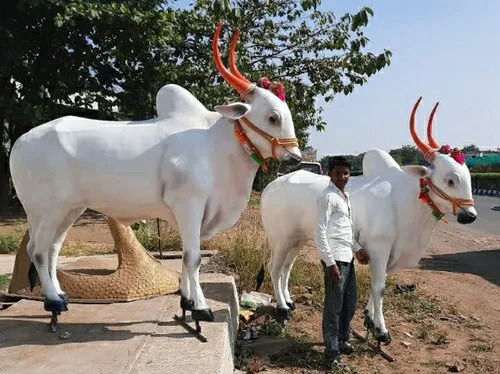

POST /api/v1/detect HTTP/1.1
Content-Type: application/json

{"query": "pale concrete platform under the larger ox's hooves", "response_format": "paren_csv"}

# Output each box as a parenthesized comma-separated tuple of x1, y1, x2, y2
(0, 274, 238, 374)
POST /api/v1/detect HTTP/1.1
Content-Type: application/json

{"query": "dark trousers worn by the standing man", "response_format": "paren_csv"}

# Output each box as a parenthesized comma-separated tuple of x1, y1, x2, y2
(321, 261, 357, 358)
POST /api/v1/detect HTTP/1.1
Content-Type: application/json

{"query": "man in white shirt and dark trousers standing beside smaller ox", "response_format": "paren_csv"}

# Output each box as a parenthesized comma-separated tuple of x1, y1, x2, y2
(315, 156, 368, 366)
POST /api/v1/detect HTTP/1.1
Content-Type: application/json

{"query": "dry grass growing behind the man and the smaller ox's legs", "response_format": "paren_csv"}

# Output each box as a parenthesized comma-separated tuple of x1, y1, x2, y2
(203, 202, 441, 323)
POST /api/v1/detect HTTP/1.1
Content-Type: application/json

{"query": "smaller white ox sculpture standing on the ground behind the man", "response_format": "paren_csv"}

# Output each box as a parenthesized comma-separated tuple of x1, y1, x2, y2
(261, 99, 477, 342)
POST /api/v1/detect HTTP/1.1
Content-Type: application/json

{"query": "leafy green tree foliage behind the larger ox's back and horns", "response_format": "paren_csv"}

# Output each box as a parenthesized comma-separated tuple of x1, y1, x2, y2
(0, 0, 391, 210)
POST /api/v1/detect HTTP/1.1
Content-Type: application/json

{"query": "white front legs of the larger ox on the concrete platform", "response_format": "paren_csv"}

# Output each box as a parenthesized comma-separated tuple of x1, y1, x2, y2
(175, 201, 214, 322)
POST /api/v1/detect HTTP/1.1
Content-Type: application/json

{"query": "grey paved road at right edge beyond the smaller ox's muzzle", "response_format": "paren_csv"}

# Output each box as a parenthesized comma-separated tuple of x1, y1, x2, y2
(448, 195, 500, 235)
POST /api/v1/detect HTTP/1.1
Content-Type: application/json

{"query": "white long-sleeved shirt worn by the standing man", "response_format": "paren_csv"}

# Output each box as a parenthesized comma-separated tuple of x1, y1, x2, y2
(315, 181, 361, 266)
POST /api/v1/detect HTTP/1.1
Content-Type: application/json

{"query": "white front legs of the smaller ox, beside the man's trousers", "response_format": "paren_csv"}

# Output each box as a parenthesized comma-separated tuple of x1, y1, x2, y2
(370, 251, 391, 343)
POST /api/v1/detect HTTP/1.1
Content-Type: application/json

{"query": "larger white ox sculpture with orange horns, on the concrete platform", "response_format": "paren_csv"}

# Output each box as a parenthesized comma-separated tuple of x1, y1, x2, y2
(10, 23, 301, 321)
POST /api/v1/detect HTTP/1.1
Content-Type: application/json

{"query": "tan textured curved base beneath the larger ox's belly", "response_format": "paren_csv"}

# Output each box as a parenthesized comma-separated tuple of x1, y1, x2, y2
(9, 218, 179, 302)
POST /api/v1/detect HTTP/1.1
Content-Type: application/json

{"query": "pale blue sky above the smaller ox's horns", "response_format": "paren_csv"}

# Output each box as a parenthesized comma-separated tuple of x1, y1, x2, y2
(309, 0, 500, 157)
